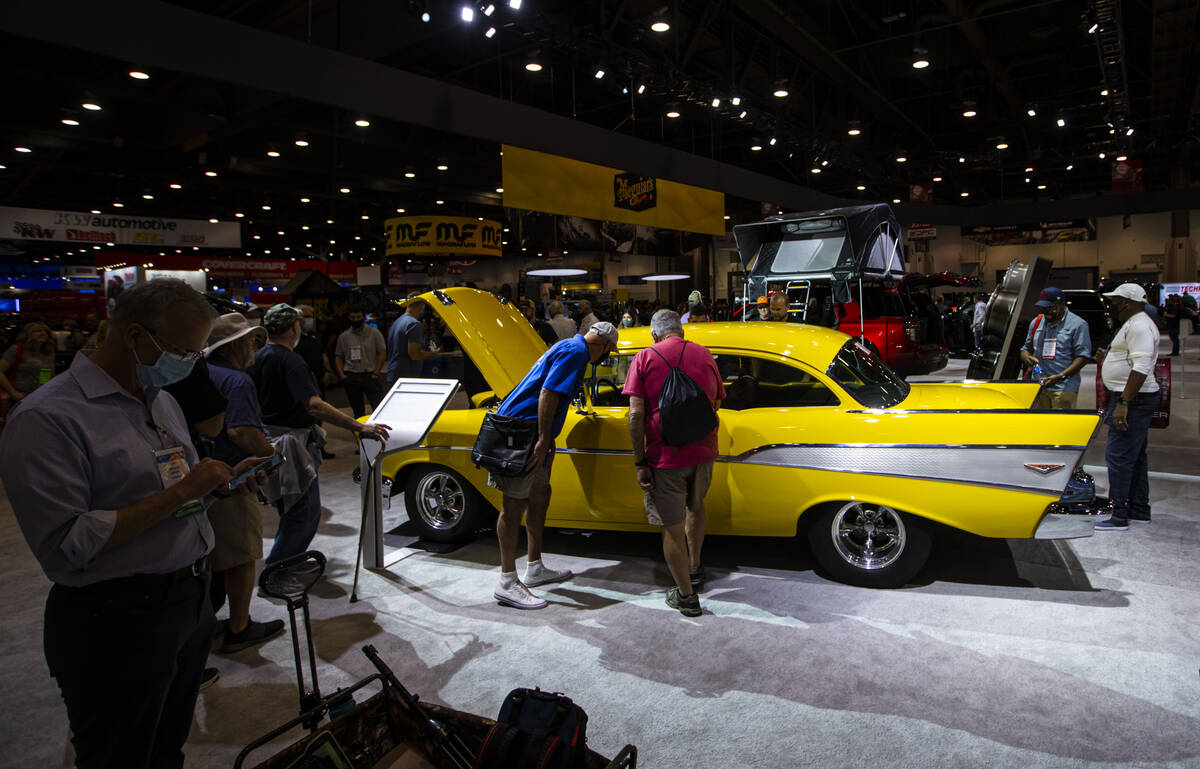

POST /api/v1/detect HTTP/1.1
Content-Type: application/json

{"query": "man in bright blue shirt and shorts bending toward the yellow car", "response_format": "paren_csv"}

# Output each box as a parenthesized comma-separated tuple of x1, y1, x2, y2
(487, 322, 617, 608)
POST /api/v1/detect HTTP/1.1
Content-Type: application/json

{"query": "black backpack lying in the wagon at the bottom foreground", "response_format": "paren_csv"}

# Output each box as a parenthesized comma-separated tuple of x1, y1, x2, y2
(475, 689, 588, 769)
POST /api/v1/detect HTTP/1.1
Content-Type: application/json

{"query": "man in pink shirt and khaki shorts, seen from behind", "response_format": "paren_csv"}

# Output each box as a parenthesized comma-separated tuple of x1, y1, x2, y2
(624, 310, 725, 617)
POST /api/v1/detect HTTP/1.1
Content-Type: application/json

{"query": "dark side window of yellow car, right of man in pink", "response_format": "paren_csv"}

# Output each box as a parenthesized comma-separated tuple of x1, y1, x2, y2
(714, 354, 841, 411)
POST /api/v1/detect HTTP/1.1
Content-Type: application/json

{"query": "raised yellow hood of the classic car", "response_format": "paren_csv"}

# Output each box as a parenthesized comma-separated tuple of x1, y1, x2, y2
(421, 288, 546, 398)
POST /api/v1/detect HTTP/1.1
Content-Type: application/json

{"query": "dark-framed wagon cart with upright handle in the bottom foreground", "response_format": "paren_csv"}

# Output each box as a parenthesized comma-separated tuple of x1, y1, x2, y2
(234, 551, 637, 769)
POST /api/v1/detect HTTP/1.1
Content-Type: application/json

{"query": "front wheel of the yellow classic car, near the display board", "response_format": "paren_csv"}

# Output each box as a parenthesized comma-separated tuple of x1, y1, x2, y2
(404, 464, 485, 543)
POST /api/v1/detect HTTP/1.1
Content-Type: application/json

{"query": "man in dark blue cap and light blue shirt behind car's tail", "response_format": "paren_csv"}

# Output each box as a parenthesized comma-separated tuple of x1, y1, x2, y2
(1021, 286, 1092, 409)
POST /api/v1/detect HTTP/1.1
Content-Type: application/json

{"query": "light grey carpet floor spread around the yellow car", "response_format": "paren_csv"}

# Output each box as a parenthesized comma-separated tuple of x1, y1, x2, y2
(0, 338, 1200, 769)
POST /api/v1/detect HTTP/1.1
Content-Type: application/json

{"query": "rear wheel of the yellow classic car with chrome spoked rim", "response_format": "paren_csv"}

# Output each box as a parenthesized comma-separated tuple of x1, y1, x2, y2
(809, 501, 932, 588)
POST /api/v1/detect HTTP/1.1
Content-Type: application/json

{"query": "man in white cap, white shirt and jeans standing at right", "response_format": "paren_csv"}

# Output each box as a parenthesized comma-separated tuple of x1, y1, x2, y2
(1096, 283, 1159, 531)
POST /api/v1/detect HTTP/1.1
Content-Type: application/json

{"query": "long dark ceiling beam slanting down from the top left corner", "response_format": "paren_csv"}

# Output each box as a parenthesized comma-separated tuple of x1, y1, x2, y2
(0, 0, 841, 210)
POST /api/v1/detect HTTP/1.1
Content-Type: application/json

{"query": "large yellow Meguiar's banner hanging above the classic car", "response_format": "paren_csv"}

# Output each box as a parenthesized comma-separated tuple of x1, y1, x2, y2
(503, 144, 725, 235)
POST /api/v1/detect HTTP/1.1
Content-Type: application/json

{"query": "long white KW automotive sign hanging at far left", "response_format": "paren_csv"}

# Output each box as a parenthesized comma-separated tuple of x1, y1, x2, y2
(0, 206, 241, 248)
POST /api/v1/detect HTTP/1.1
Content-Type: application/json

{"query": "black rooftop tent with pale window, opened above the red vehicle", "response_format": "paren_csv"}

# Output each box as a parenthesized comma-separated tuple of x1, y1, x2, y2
(733, 203, 905, 290)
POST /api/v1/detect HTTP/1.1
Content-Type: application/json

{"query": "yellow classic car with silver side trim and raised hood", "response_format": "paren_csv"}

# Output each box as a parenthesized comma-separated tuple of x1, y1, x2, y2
(372, 288, 1099, 587)
